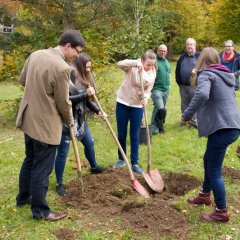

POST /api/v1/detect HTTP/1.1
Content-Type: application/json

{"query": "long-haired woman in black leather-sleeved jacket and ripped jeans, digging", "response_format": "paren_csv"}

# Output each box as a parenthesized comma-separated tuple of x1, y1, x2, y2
(55, 53, 107, 196)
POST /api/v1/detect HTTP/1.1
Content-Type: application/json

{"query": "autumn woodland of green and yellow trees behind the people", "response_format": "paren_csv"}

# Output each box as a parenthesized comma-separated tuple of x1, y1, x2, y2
(0, 0, 240, 89)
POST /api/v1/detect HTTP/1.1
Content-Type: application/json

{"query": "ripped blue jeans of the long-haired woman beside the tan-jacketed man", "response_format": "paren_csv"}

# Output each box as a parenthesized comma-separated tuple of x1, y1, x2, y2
(55, 126, 97, 184)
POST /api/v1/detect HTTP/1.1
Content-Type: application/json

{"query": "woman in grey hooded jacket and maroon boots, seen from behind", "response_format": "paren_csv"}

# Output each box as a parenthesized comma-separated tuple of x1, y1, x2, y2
(182, 47, 240, 222)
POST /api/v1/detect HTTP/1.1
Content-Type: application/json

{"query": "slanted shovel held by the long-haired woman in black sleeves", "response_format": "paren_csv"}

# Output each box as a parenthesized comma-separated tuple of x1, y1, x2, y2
(93, 95, 150, 198)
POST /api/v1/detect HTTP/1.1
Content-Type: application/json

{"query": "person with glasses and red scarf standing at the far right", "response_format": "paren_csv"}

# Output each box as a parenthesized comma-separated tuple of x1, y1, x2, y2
(219, 40, 240, 91)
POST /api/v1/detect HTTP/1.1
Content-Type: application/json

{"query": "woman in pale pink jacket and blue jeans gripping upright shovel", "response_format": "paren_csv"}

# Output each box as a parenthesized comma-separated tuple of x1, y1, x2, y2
(113, 50, 156, 174)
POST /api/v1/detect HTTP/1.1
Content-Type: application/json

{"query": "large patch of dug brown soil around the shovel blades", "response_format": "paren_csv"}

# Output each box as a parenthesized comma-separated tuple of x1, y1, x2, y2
(59, 168, 200, 239)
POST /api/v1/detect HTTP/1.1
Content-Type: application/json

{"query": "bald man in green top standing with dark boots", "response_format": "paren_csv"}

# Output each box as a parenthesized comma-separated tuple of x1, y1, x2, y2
(151, 44, 171, 134)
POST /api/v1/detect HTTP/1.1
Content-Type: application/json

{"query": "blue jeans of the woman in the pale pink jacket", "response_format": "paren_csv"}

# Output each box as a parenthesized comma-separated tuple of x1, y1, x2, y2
(116, 102, 143, 165)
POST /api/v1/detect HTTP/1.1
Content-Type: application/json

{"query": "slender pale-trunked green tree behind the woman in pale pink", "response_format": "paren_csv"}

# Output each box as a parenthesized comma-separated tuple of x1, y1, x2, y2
(112, 0, 163, 59)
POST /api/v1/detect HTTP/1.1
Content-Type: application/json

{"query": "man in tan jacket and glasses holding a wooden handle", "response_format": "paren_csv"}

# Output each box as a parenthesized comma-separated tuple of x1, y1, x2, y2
(16, 30, 85, 221)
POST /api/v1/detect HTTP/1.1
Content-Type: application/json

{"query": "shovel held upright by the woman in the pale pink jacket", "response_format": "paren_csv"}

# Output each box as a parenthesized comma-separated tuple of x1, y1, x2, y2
(140, 73, 164, 192)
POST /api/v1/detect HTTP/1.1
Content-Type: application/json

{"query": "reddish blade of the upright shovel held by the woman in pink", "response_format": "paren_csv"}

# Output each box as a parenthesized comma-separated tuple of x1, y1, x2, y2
(143, 169, 164, 193)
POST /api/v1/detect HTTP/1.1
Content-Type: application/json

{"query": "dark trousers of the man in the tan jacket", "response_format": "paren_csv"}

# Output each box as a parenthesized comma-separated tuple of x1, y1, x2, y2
(16, 134, 57, 219)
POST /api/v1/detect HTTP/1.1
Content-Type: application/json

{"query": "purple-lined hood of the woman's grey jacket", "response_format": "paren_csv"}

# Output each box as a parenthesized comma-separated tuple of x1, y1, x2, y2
(199, 64, 235, 86)
